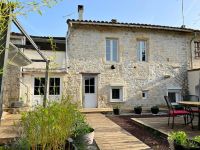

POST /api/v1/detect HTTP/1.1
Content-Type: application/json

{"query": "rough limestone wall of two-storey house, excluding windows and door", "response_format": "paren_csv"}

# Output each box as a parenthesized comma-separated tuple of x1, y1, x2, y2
(67, 25, 191, 107)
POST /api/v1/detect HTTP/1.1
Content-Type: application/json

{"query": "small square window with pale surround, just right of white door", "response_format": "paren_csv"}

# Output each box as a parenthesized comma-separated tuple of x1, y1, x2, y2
(110, 86, 123, 102)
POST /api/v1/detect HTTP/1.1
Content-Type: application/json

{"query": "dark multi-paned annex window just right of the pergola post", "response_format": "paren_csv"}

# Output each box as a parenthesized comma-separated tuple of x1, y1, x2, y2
(49, 78, 60, 95)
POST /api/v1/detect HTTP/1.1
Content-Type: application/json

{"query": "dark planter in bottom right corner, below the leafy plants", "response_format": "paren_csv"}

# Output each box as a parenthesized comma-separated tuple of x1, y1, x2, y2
(174, 140, 200, 150)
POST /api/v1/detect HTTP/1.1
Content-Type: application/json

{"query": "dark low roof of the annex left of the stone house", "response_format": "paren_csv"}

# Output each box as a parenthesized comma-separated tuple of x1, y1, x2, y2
(11, 32, 65, 51)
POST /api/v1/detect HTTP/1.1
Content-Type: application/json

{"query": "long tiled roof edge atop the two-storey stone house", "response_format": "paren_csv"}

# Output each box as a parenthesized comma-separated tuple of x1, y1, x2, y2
(67, 19, 200, 32)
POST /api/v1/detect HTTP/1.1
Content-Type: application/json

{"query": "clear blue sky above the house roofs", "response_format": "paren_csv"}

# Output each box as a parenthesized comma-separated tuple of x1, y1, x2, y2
(12, 0, 200, 36)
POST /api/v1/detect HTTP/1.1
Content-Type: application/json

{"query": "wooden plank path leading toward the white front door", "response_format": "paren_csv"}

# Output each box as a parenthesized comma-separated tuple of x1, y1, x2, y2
(86, 113, 150, 150)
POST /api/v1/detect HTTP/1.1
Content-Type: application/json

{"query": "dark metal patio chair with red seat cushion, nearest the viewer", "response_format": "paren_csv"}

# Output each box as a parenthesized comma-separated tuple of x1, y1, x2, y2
(164, 96, 193, 129)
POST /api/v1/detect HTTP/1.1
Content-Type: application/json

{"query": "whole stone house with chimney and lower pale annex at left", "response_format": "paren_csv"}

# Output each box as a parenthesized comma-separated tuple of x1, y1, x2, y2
(5, 6, 200, 108)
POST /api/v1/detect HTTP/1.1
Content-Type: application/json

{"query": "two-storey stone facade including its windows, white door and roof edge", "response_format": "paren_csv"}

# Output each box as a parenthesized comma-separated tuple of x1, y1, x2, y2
(66, 20, 199, 108)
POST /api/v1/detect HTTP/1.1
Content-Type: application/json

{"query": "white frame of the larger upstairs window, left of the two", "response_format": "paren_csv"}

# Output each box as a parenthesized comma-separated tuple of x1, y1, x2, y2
(106, 38, 119, 62)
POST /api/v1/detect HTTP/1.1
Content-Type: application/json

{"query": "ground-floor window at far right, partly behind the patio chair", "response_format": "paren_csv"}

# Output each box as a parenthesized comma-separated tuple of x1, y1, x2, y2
(168, 89, 181, 103)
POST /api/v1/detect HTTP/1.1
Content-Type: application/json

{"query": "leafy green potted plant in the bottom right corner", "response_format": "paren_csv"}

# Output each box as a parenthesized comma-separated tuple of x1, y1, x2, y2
(168, 131, 200, 150)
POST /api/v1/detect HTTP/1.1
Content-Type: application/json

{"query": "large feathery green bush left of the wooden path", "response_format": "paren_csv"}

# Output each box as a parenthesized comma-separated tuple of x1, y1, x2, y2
(21, 98, 84, 150)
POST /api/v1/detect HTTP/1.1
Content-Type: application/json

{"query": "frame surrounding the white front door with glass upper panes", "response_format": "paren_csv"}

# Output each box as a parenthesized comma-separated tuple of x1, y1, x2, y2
(82, 73, 99, 108)
